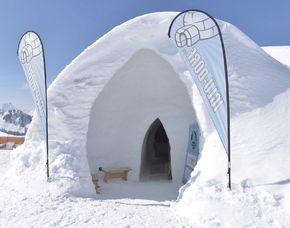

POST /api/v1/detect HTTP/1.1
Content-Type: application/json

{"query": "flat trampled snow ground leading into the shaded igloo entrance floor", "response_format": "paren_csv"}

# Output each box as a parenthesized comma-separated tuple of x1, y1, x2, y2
(0, 150, 184, 228)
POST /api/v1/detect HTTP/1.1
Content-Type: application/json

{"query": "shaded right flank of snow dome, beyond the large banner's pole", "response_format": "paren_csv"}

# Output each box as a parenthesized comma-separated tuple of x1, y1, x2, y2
(221, 23, 290, 116)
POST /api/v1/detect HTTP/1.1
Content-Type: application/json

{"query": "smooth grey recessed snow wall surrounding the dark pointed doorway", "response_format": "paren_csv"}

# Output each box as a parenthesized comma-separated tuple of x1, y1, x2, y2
(87, 49, 196, 182)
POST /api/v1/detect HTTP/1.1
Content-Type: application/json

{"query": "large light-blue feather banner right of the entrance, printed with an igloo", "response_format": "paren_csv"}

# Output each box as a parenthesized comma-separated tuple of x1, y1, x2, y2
(168, 10, 230, 154)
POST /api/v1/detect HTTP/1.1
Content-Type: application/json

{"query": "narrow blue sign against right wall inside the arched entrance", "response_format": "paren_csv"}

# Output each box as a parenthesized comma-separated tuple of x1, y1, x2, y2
(182, 123, 200, 184)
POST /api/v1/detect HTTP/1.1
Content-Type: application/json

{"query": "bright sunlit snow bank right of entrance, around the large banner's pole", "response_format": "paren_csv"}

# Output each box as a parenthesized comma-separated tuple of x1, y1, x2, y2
(176, 90, 290, 227)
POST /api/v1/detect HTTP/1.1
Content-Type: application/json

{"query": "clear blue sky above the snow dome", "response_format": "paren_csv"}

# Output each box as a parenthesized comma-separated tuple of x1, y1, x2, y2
(0, 0, 290, 111)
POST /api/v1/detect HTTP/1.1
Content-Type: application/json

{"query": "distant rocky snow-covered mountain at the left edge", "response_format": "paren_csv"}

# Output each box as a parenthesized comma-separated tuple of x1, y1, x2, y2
(0, 103, 32, 135)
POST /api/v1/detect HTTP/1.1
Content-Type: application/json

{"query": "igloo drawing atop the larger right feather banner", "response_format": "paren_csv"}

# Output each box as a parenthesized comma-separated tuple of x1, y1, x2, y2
(175, 12, 218, 47)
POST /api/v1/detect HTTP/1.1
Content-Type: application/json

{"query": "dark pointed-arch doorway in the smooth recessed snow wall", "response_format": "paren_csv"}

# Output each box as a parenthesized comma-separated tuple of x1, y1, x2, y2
(140, 119, 172, 180)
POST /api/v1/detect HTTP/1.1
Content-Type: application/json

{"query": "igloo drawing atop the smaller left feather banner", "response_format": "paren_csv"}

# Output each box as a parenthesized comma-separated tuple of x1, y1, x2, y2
(20, 32, 42, 64)
